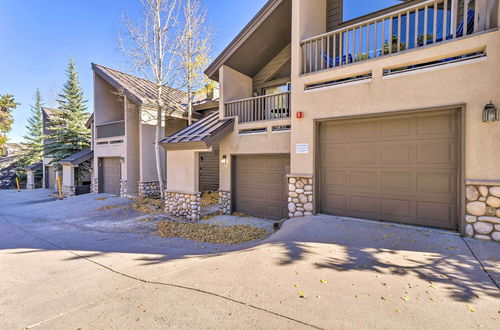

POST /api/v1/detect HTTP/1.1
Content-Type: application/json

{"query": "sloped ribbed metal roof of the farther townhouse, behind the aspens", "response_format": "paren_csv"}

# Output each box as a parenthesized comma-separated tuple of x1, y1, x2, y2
(92, 63, 187, 114)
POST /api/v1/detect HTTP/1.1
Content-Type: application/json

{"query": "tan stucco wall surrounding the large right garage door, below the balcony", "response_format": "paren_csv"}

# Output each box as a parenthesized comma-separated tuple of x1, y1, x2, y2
(291, 31, 500, 180)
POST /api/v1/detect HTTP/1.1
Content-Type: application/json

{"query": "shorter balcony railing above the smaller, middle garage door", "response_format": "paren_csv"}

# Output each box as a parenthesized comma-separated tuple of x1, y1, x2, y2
(225, 92, 290, 123)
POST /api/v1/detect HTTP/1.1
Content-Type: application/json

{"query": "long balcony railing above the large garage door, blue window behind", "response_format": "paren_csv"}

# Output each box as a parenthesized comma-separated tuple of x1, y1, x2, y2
(301, 0, 498, 74)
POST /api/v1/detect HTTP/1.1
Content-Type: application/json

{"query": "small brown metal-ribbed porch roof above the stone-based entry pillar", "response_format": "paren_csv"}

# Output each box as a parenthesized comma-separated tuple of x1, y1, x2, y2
(161, 112, 234, 150)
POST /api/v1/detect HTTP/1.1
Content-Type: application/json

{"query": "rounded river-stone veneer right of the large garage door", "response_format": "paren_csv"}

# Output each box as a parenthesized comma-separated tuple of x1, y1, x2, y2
(465, 184, 500, 242)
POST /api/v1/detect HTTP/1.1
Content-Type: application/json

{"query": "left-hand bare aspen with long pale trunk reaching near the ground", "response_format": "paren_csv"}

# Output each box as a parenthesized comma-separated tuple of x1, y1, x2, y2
(118, 0, 180, 198)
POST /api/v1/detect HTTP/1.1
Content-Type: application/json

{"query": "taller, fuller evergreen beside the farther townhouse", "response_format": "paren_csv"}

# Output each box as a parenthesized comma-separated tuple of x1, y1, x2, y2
(45, 58, 90, 170)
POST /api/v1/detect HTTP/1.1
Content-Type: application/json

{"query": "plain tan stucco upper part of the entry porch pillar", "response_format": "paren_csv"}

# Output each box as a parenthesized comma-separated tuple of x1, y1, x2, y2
(167, 150, 201, 194)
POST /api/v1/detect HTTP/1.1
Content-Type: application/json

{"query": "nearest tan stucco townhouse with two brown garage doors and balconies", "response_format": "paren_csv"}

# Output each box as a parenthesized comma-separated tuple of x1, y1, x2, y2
(164, 0, 500, 240)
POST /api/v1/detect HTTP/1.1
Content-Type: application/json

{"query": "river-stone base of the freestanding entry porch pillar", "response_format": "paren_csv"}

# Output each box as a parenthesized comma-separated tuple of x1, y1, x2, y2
(165, 191, 201, 221)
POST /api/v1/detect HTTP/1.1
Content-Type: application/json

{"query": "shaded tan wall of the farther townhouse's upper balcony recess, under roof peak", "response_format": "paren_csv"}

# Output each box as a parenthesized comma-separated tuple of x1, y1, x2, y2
(94, 73, 125, 125)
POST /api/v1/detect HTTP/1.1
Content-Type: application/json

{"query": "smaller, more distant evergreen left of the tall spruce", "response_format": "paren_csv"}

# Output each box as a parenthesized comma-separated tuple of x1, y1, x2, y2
(19, 89, 43, 170)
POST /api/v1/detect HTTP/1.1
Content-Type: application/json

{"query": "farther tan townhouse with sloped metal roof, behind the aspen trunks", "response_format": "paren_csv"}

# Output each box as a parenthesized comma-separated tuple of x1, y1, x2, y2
(90, 64, 218, 197)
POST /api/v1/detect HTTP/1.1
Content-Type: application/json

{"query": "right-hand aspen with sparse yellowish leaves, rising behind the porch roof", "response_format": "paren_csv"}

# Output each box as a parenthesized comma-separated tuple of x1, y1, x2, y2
(177, 0, 213, 125)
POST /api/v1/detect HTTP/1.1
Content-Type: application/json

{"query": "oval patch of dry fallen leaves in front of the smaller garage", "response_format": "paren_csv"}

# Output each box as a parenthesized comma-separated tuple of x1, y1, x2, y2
(156, 220, 270, 245)
